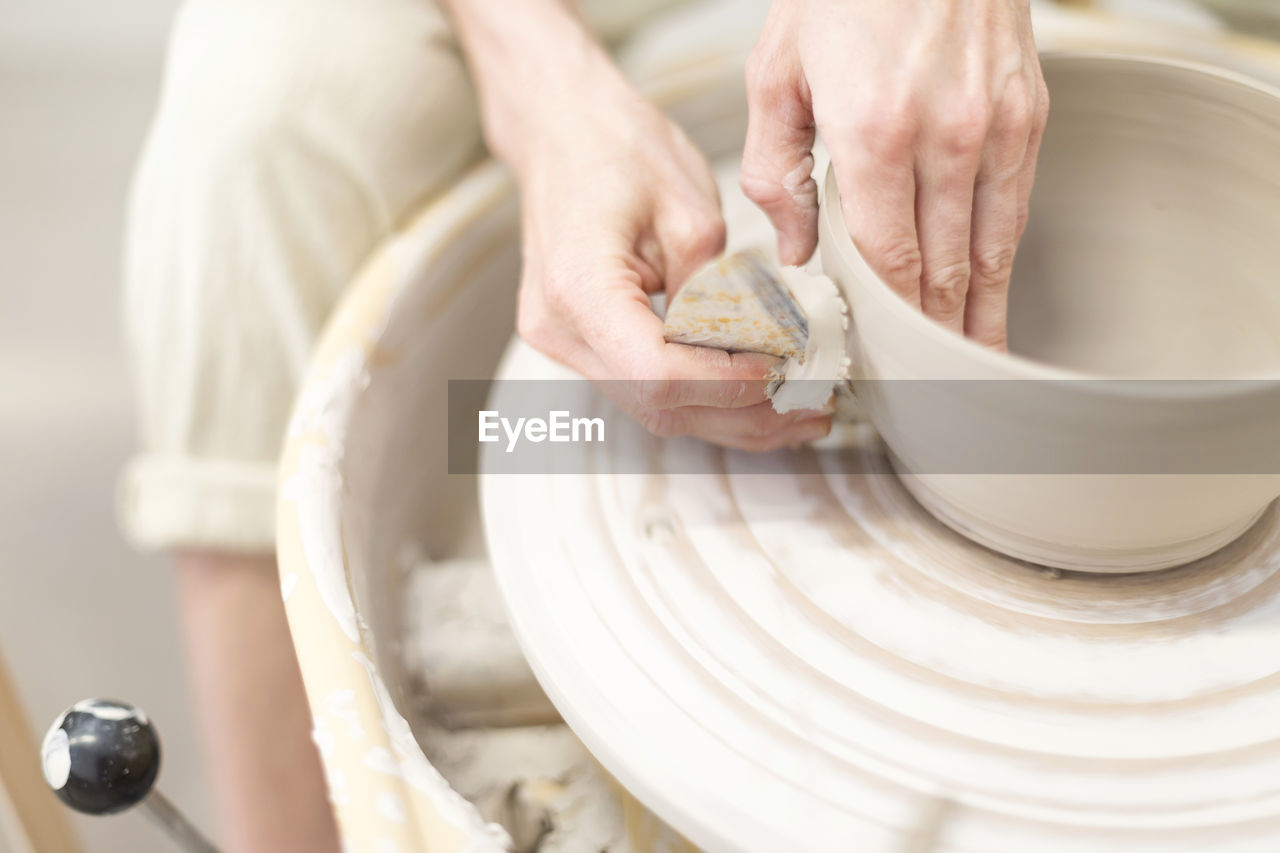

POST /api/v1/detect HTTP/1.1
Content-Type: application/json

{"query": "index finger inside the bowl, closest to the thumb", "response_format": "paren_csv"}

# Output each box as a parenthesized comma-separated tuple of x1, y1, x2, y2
(823, 127, 920, 307)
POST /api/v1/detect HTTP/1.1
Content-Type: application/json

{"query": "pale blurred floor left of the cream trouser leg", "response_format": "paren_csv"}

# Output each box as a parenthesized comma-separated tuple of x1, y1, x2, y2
(0, 51, 212, 853)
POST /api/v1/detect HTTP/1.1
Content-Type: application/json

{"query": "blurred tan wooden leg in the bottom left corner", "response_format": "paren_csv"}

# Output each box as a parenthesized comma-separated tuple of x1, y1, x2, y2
(0, 648, 81, 853)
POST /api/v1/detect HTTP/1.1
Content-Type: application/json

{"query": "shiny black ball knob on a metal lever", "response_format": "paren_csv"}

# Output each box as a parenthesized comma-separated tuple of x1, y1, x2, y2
(44, 699, 160, 815)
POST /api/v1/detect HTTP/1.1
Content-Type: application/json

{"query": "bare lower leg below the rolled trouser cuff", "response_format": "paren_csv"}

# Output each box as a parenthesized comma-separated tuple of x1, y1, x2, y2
(177, 552, 338, 853)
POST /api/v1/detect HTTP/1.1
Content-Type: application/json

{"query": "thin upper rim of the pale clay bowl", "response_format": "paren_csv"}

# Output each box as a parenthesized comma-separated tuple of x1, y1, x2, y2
(818, 50, 1280, 402)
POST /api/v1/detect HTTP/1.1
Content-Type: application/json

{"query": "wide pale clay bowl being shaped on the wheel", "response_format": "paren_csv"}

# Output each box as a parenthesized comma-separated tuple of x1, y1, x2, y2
(820, 54, 1280, 573)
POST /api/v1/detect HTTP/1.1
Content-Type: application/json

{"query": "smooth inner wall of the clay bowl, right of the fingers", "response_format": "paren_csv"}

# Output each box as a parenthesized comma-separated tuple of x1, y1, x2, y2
(1009, 53, 1280, 371)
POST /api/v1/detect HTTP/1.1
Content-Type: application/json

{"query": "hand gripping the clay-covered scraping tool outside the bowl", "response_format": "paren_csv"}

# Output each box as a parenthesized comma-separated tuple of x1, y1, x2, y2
(465, 9, 831, 451)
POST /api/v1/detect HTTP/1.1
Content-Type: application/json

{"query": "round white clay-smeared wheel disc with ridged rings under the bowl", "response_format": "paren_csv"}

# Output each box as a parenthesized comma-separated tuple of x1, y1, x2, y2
(484, 159, 1280, 853)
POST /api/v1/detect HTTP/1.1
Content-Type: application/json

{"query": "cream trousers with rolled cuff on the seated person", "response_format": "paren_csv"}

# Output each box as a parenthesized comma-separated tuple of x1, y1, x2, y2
(119, 0, 691, 552)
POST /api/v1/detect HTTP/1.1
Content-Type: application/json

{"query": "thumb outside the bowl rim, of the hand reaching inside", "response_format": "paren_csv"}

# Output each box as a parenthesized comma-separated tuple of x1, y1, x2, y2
(739, 45, 818, 264)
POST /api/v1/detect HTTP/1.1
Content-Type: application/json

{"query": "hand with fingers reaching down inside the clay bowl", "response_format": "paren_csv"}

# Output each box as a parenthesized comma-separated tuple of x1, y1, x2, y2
(741, 0, 1048, 350)
